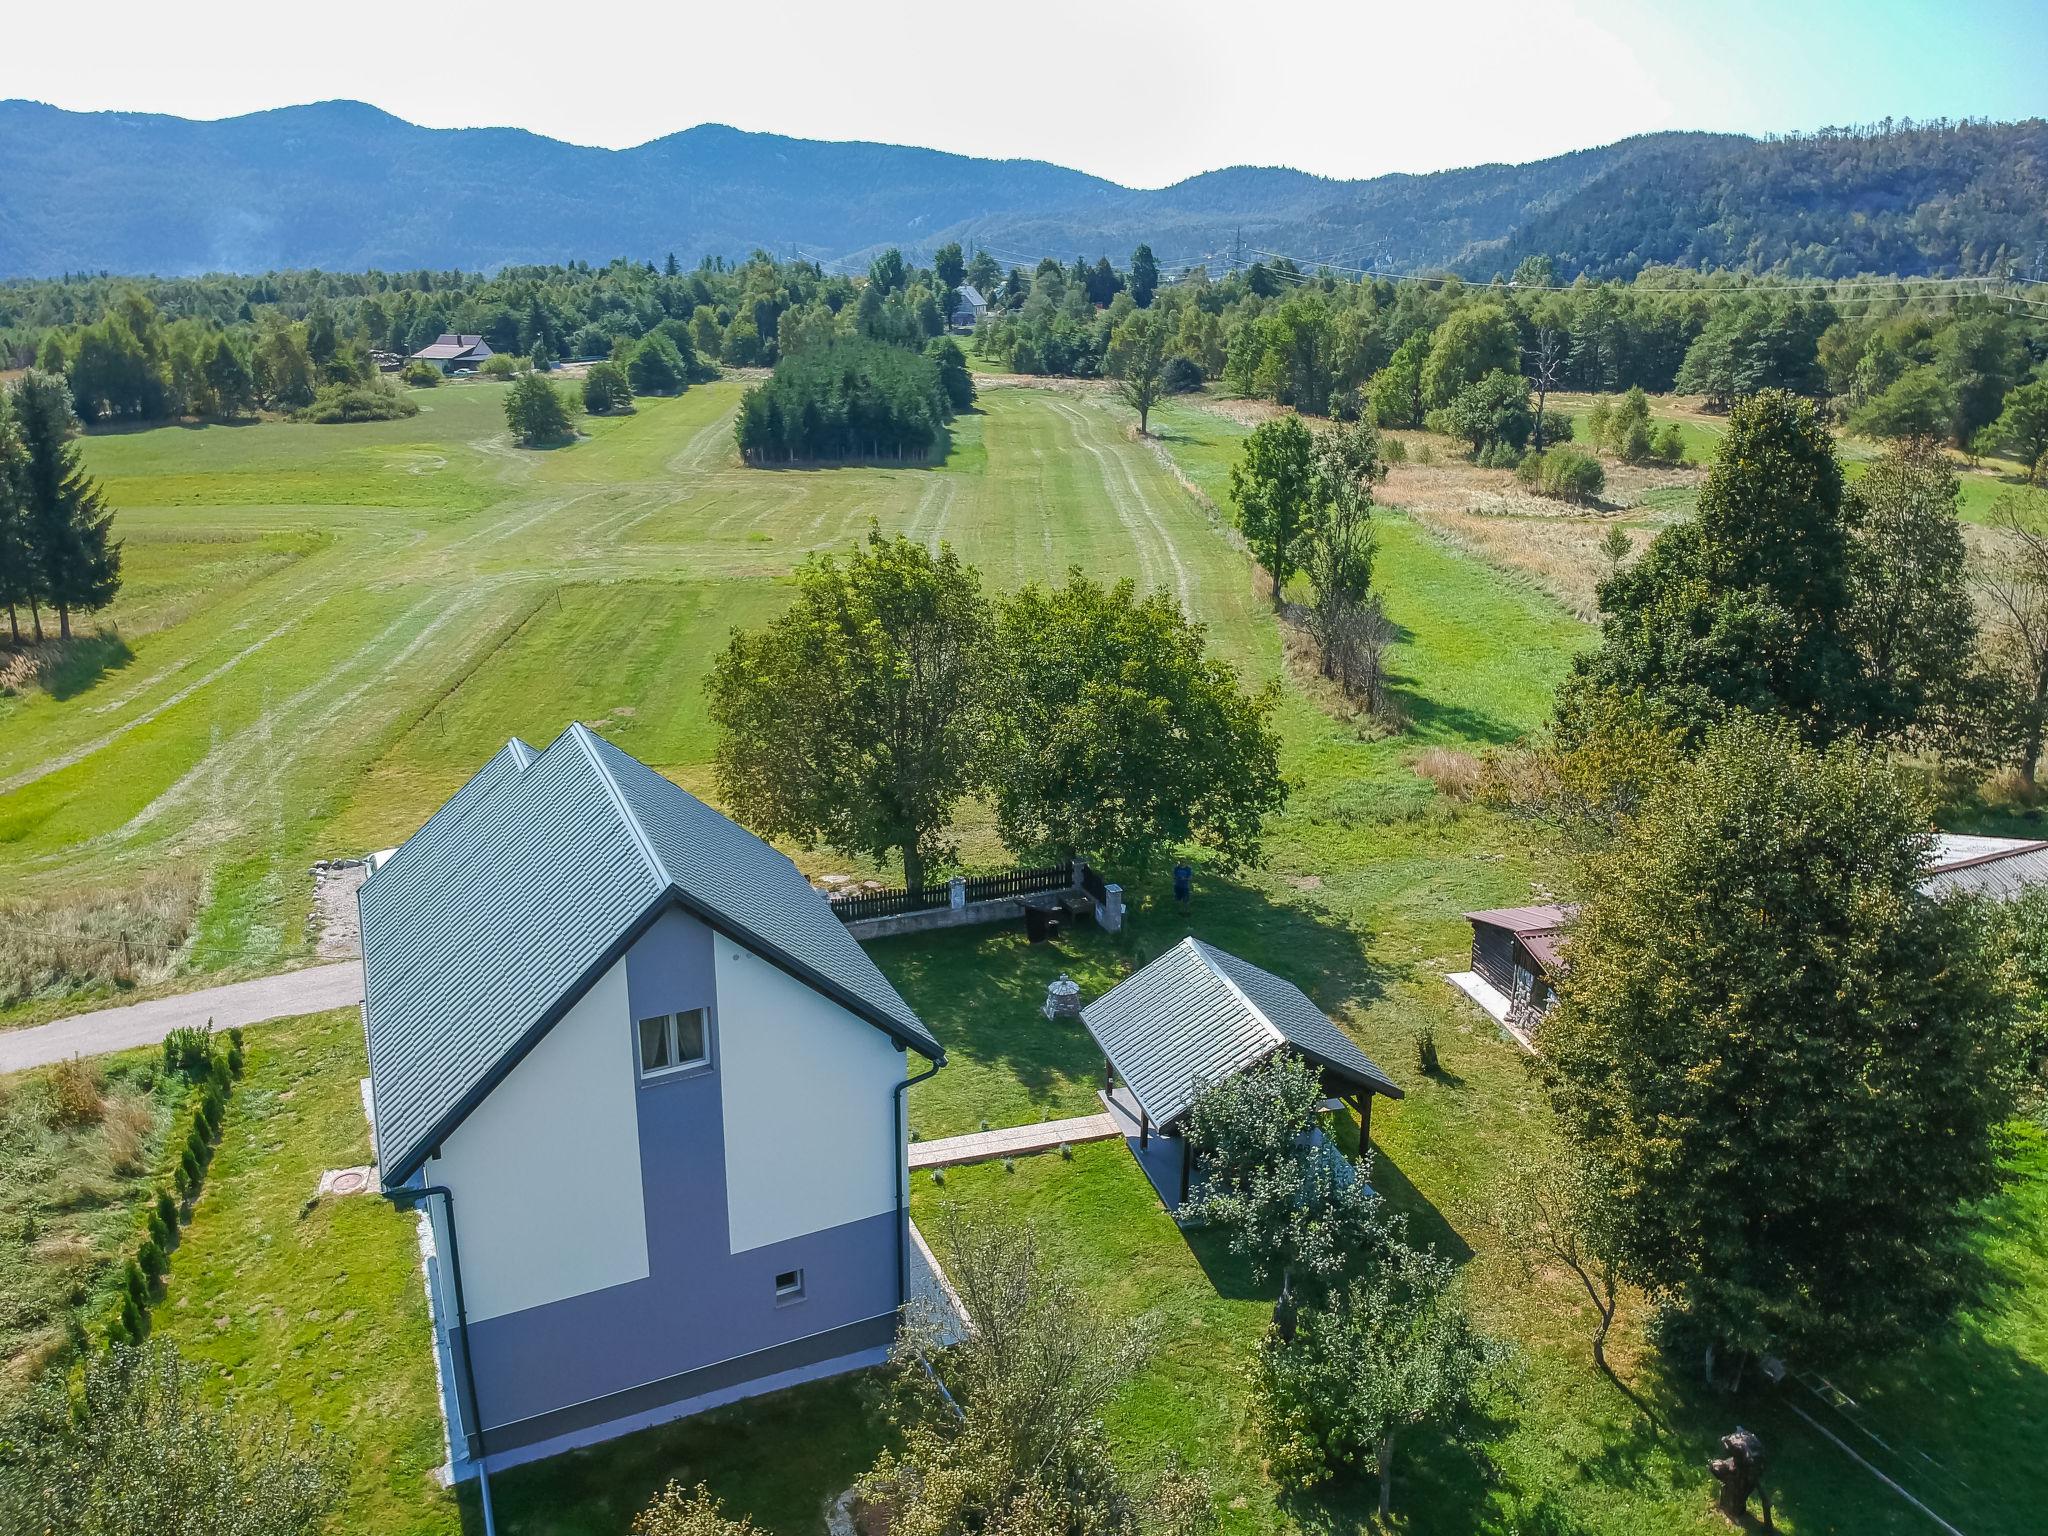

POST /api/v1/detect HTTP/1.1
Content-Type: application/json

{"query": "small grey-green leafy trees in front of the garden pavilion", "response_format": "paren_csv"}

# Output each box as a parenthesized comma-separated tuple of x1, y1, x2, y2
(1180, 1051, 1511, 1520)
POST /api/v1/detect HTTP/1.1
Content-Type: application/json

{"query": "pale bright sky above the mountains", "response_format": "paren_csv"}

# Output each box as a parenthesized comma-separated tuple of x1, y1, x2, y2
(0, 0, 2048, 186)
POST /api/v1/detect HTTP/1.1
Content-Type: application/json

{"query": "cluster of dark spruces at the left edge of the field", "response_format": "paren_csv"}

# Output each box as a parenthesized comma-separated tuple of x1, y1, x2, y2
(0, 369, 121, 645)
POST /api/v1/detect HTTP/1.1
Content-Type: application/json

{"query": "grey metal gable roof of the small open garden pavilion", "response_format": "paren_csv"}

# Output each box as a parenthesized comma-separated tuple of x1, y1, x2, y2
(1081, 938, 1401, 1126)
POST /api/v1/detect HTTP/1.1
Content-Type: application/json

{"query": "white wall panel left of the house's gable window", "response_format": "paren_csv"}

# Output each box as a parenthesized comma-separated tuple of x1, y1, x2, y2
(426, 961, 647, 1321)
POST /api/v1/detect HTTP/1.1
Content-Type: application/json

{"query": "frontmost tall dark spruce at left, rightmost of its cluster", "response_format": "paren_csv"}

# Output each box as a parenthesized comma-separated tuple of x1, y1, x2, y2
(14, 371, 121, 639)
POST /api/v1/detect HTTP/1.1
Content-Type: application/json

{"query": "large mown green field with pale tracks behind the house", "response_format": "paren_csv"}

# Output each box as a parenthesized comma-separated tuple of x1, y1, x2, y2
(0, 381, 1278, 1022)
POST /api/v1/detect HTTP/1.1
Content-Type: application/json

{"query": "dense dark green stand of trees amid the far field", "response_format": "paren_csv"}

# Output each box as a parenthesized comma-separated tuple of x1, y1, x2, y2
(733, 336, 975, 465)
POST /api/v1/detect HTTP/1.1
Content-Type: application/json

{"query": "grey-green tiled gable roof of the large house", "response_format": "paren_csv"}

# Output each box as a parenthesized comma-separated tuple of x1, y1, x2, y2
(358, 725, 944, 1184)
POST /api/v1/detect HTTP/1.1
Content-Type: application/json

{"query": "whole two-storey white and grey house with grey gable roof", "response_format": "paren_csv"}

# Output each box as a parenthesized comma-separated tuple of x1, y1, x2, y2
(358, 725, 944, 1477)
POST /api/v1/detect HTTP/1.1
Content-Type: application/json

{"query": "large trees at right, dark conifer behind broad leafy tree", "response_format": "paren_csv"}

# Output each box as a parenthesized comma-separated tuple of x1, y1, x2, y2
(1466, 391, 2048, 1384)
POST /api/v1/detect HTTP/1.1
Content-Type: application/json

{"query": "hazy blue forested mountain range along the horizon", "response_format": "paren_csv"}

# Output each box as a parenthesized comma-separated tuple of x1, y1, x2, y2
(0, 100, 2048, 281)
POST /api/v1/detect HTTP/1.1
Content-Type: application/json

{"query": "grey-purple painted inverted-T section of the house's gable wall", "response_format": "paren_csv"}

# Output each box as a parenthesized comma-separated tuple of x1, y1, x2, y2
(455, 909, 897, 1432)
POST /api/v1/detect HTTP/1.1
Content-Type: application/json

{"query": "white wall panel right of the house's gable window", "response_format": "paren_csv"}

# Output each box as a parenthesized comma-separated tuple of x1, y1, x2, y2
(715, 936, 903, 1253)
